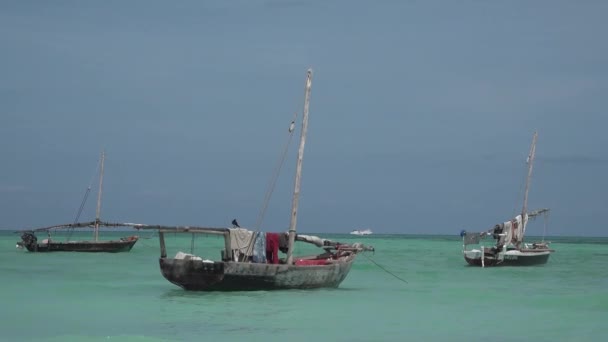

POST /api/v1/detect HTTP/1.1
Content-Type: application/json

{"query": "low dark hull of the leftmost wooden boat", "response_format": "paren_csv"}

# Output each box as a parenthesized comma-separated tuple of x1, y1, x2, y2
(25, 237, 138, 253)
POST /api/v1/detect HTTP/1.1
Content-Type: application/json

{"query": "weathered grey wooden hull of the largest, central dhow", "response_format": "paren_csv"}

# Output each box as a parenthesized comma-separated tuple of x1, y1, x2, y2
(159, 255, 355, 291)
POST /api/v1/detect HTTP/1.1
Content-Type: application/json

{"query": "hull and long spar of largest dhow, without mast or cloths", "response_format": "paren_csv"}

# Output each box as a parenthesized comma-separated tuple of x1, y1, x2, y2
(137, 225, 373, 291)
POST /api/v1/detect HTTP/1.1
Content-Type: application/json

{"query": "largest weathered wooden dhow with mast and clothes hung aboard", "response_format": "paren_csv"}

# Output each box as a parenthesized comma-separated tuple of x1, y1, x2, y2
(136, 70, 373, 291)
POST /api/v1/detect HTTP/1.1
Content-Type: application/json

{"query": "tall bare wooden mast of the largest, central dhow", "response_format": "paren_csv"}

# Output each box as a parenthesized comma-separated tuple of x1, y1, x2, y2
(287, 69, 312, 265)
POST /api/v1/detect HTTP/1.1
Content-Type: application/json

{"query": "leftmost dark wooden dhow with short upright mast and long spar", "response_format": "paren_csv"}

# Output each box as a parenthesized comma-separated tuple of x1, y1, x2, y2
(17, 152, 139, 253)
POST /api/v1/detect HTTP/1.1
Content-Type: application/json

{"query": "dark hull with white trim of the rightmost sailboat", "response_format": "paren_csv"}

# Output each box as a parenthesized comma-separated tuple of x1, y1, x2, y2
(464, 249, 553, 267)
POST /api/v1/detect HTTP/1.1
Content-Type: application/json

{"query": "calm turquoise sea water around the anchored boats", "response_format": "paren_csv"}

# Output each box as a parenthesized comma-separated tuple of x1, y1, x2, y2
(0, 232, 608, 341)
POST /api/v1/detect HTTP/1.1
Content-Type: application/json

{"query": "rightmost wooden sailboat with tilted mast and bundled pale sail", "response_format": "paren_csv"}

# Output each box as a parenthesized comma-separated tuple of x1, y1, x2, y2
(461, 132, 555, 267)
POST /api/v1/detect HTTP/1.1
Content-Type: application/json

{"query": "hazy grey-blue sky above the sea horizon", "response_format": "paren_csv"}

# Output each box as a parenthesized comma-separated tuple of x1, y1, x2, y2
(0, 0, 608, 236)
